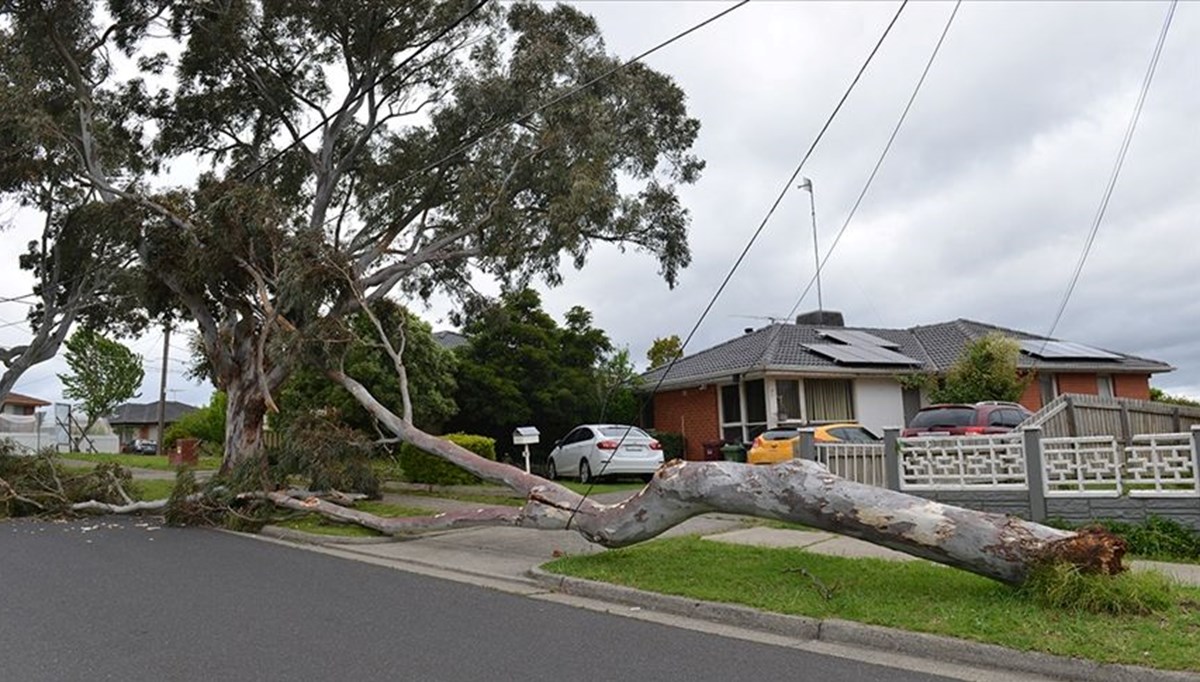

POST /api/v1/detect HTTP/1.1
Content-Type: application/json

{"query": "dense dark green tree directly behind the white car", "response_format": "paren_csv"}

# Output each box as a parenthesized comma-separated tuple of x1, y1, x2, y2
(450, 288, 612, 451)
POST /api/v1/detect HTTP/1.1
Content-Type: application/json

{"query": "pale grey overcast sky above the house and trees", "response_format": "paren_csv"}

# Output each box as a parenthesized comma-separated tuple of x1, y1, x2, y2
(0, 0, 1200, 403)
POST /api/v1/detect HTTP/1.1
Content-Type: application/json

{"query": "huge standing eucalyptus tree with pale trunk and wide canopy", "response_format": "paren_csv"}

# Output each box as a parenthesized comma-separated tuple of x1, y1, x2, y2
(4, 0, 702, 467)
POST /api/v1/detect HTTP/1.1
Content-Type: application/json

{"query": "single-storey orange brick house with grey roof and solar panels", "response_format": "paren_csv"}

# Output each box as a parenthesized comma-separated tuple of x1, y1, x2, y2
(642, 311, 1174, 459)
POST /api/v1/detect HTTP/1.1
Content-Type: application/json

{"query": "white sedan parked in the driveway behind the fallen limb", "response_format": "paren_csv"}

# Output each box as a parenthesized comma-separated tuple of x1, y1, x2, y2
(546, 424, 662, 483)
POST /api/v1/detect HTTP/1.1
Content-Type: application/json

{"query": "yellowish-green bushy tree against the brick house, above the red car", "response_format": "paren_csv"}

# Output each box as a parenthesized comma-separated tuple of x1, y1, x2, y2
(930, 334, 1028, 402)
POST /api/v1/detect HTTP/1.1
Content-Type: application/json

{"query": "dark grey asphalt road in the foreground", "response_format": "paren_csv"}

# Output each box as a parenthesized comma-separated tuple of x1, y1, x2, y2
(0, 519, 944, 682)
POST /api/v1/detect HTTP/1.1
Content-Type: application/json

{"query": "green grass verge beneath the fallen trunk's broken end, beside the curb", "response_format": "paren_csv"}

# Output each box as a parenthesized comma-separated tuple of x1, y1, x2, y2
(545, 538, 1200, 671)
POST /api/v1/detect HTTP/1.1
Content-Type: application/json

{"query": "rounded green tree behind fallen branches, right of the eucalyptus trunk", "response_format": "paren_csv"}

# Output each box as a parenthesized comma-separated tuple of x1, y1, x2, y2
(272, 299, 457, 436)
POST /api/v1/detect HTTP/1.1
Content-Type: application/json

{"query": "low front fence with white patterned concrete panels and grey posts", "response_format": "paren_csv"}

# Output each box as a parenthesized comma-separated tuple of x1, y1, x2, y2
(797, 425, 1200, 531)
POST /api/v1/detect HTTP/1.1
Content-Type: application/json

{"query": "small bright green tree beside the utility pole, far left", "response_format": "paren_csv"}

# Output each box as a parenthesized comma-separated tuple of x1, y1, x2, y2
(59, 328, 145, 432)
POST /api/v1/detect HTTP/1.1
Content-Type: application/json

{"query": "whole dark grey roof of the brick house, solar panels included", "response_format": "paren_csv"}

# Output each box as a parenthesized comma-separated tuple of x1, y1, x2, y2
(642, 319, 1174, 387)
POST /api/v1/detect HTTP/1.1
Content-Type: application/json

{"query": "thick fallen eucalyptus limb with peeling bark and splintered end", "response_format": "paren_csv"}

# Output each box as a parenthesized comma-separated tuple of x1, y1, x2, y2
(319, 371, 1124, 585)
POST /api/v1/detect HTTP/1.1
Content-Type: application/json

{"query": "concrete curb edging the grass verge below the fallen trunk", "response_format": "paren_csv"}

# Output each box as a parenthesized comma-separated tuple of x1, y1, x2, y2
(529, 567, 1200, 682)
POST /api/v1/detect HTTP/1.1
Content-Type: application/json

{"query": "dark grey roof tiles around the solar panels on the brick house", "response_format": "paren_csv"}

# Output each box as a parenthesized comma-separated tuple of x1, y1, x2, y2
(642, 319, 1172, 387)
